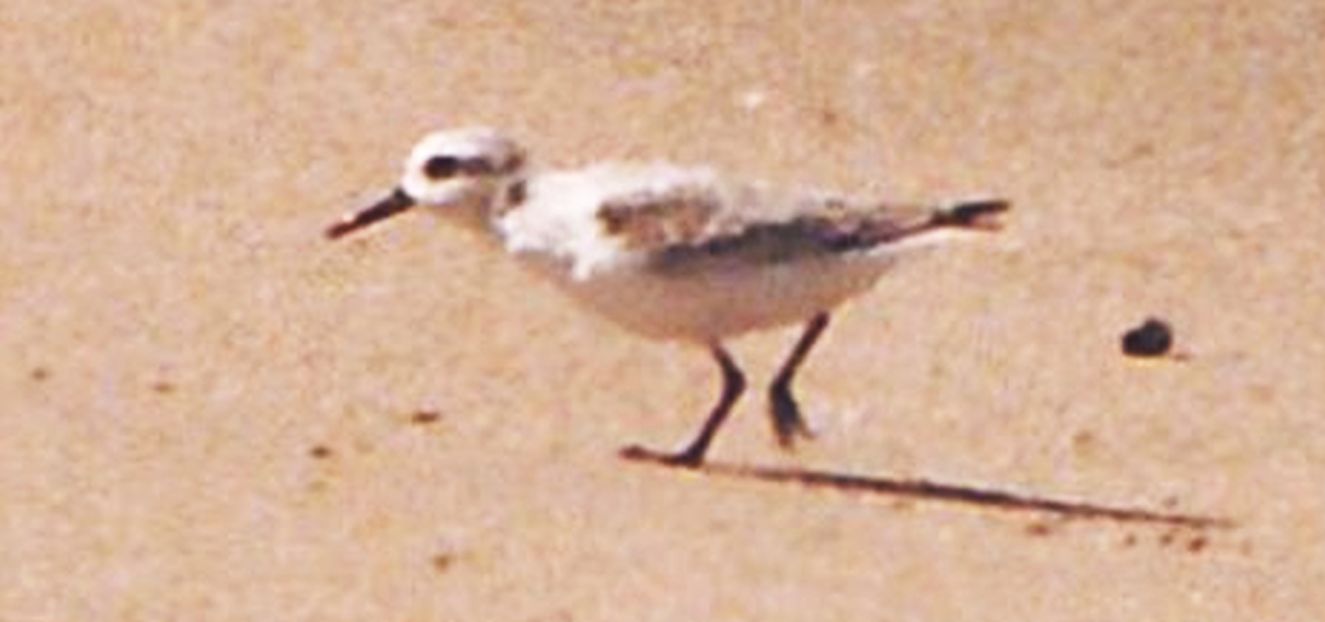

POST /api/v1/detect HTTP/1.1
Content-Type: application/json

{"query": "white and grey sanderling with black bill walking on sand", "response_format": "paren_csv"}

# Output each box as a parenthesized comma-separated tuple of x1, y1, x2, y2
(326, 127, 1008, 467)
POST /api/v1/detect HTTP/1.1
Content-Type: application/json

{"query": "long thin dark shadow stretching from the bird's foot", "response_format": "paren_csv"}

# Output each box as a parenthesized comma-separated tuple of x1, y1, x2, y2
(624, 455, 1236, 529)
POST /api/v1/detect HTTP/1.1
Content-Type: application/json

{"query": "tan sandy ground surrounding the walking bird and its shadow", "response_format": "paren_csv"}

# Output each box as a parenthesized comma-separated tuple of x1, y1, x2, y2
(0, 0, 1325, 622)
